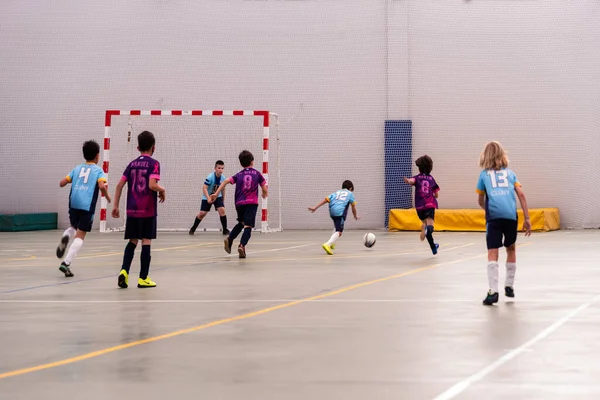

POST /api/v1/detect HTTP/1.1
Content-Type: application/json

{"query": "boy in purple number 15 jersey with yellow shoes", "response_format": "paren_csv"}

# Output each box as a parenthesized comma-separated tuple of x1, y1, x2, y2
(112, 131, 166, 289)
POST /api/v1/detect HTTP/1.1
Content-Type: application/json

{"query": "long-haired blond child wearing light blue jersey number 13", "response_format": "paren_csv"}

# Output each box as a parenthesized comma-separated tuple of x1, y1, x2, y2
(477, 142, 531, 306)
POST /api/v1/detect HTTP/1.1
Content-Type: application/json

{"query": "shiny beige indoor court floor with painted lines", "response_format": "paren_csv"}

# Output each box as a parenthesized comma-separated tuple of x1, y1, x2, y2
(0, 231, 600, 399)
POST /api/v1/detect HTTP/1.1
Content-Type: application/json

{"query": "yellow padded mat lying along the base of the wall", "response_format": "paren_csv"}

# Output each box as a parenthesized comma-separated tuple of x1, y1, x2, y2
(388, 208, 560, 232)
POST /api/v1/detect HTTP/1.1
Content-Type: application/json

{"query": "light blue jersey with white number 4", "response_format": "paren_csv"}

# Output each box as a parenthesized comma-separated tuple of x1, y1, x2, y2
(66, 163, 106, 214)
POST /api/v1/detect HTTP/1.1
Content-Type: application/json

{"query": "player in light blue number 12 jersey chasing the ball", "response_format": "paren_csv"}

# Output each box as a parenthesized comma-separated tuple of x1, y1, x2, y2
(308, 180, 360, 256)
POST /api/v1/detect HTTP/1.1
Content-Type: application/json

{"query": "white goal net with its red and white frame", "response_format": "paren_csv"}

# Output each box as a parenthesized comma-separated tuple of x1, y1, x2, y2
(100, 110, 281, 232)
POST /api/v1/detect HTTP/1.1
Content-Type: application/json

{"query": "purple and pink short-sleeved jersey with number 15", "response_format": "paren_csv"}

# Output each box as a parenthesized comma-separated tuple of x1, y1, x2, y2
(121, 155, 160, 218)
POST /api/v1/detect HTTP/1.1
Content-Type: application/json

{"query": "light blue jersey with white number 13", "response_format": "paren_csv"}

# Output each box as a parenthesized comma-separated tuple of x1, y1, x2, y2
(477, 168, 521, 221)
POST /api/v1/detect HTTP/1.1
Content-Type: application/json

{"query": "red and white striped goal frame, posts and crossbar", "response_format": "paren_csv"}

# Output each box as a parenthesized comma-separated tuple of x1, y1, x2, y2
(100, 110, 281, 232)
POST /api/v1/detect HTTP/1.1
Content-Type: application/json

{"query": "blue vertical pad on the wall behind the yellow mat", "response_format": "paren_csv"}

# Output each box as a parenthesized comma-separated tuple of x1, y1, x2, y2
(384, 120, 412, 227)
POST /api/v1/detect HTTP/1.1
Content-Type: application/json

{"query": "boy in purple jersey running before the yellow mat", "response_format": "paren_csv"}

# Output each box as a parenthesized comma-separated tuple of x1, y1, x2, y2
(404, 155, 440, 255)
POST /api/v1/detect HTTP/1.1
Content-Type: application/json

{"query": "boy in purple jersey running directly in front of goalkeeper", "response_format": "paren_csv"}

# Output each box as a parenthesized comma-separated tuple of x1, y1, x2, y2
(210, 150, 267, 258)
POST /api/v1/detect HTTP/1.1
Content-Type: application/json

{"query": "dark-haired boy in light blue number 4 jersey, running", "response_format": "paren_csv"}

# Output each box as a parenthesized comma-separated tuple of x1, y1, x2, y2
(56, 140, 111, 278)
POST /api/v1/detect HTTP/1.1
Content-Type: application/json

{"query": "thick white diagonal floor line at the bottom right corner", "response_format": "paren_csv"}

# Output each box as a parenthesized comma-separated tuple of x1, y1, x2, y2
(434, 295, 600, 400)
